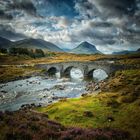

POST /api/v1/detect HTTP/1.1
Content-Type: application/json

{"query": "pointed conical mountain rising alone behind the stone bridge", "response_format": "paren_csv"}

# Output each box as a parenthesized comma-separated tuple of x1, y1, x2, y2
(71, 41, 102, 54)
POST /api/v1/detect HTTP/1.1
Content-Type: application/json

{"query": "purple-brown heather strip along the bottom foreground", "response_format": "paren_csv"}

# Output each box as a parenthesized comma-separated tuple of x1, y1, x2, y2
(0, 110, 130, 140)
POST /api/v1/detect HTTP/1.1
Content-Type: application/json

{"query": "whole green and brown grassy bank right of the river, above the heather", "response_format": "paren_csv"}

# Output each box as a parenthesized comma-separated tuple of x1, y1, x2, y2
(37, 70, 140, 139)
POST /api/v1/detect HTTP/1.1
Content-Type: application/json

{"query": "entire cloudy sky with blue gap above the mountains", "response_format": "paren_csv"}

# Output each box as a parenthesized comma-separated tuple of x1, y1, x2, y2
(0, 0, 140, 53)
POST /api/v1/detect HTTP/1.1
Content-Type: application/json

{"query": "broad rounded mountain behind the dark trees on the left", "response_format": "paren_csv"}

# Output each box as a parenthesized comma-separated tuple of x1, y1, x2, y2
(11, 38, 64, 52)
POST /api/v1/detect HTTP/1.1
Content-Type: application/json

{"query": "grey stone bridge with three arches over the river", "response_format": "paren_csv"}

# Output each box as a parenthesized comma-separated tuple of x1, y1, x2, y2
(36, 60, 125, 77)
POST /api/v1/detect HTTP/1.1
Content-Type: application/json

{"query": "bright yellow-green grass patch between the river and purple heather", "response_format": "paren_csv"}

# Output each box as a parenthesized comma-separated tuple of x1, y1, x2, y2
(37, 97, 111, 128)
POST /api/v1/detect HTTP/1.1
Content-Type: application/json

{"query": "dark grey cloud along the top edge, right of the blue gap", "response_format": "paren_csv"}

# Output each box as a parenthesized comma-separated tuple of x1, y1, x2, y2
(76, 0, 137, 18)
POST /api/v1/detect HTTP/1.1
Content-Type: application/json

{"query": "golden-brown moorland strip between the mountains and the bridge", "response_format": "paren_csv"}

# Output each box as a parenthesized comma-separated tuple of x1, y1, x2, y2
(0, 52, 140, 65)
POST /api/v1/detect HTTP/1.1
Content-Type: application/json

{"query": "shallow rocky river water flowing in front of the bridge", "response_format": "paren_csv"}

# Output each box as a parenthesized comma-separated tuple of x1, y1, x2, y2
(0, 77, 86, 111)
